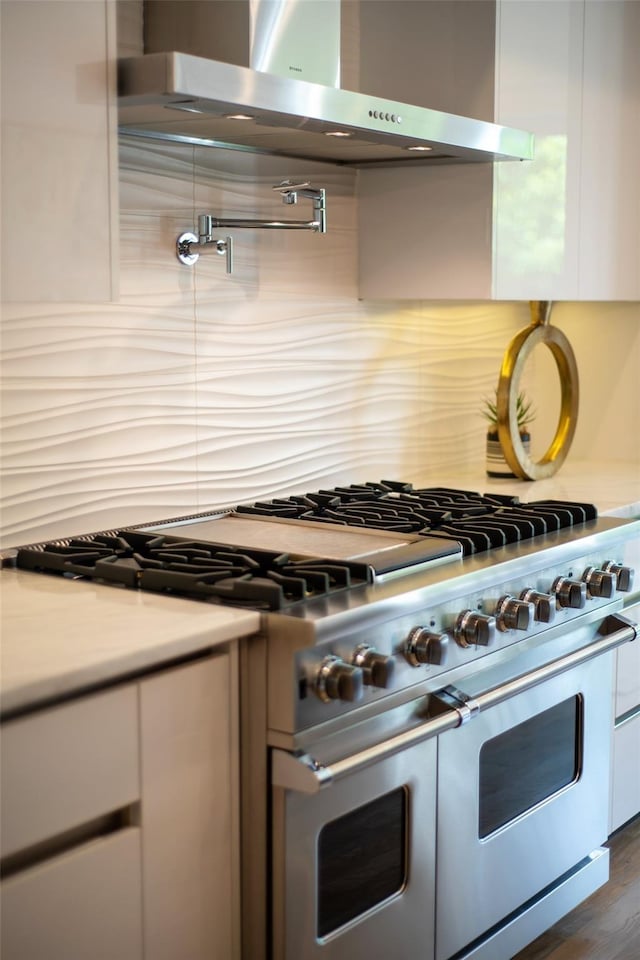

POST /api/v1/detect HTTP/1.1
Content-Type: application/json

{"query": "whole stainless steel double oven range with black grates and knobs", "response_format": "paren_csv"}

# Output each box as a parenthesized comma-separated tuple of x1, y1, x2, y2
(7, 482, 640, 960)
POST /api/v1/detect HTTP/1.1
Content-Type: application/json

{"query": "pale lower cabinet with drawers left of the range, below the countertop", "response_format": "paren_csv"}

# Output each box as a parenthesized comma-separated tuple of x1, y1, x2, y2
(0, 651, 240, 960)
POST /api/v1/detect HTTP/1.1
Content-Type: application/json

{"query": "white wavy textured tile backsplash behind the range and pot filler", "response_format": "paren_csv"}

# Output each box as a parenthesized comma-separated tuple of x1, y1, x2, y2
(2, 133, 640, 546)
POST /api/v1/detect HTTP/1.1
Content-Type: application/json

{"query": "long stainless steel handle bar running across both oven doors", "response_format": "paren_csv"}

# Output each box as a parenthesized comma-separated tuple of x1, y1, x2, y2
(271, 613, 640, 793)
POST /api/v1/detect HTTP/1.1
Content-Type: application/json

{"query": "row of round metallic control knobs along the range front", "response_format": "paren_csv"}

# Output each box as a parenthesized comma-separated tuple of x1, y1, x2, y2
(313, 560, 633, 702)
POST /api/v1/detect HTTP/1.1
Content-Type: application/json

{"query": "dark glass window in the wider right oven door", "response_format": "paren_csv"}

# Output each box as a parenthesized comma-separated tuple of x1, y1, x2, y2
(478, 697, 582, 839)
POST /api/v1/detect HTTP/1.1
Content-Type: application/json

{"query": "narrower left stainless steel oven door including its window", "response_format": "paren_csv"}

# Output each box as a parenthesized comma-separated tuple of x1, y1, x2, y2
(272, 735, 436, 960)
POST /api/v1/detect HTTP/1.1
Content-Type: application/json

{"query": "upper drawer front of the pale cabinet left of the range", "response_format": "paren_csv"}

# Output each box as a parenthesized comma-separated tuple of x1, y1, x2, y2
(0, 685, 140, 856)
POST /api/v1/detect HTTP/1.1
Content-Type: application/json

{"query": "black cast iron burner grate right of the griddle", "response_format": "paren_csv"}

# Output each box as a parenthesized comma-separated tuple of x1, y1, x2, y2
(236, 480, 598, 556)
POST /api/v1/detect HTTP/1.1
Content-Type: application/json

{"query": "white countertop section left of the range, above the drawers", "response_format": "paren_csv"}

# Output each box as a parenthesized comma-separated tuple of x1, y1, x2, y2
(0, 569, 260, 715)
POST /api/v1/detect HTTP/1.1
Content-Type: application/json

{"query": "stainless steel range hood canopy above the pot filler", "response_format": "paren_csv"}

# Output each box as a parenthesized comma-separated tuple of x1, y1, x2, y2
(118, 0, 533, 167)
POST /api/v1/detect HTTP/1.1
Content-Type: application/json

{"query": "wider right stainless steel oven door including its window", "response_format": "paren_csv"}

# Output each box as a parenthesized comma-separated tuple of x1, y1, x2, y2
(436, 653, 612, 960)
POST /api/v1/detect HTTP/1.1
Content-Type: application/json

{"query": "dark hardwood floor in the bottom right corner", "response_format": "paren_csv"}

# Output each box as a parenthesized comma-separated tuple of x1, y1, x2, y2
(513, 816, 640, 960)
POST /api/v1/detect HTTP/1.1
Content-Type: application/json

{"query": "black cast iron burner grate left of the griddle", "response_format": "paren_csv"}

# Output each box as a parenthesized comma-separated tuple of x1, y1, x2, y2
(16, 530, 372, 610)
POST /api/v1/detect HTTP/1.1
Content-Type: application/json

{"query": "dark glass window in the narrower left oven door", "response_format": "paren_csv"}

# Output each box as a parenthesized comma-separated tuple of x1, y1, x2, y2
(318, 787, 407, 937)
